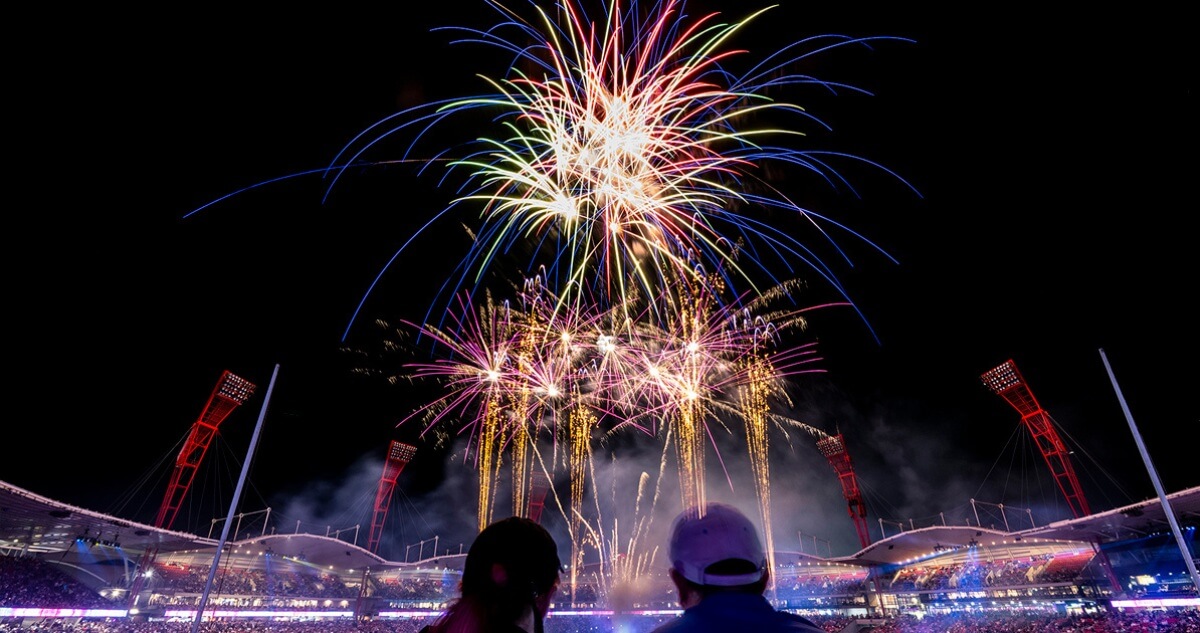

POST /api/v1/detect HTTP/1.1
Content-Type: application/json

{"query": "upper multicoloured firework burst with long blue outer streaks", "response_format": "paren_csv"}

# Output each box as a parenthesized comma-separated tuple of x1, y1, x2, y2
(332, 0, 902, 335)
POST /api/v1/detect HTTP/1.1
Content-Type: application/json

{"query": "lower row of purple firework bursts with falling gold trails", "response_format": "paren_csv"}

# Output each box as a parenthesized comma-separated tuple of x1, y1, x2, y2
(401, 269, 830, 560)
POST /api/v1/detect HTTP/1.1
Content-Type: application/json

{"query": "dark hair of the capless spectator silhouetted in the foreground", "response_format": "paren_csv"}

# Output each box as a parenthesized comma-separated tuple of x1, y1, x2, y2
(438, 517, 562, 631)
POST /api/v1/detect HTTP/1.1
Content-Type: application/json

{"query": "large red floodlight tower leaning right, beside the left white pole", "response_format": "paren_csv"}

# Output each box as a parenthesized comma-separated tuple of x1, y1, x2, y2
(154, 369, 254, 530)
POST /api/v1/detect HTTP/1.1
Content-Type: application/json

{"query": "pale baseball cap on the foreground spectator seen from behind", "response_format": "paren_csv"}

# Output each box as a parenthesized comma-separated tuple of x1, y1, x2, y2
(668, 501, 767, 586)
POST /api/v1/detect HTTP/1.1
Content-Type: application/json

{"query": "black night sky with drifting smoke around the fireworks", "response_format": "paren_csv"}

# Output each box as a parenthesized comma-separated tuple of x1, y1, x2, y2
(7, 0, 1200, 557)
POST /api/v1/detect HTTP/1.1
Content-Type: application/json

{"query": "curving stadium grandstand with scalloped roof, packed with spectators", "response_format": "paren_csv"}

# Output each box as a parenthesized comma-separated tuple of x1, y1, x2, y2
(0, 482, 1200, 633)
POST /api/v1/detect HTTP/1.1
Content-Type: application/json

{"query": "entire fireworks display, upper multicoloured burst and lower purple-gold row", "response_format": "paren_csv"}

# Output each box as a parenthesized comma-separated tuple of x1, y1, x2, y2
(187, 0, 911, 609)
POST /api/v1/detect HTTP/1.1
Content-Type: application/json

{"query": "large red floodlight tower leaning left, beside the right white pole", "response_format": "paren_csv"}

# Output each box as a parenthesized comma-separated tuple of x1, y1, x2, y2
(980, 360, 1091, 519)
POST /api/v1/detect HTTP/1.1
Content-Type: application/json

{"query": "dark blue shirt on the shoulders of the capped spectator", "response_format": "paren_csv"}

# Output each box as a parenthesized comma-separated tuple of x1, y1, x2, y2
(650, 593, 824, 633)
